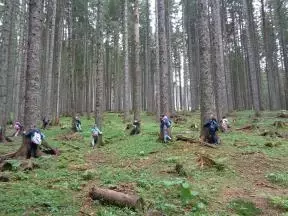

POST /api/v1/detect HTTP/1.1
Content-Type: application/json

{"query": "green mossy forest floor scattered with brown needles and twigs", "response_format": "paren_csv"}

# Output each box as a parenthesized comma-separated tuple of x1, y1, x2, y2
(0, 111, 288, 216)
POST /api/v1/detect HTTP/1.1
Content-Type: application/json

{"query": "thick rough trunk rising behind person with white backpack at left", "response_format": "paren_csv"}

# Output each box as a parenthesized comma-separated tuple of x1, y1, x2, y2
(24, 0, 42, 130)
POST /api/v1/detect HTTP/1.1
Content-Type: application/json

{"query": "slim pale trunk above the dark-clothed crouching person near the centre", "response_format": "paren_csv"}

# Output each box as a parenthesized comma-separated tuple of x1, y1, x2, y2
(133, 0, 141, 121)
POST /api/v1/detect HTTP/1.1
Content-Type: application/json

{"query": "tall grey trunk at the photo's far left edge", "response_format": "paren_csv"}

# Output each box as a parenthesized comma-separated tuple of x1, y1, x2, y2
(0, 0, 12, 134)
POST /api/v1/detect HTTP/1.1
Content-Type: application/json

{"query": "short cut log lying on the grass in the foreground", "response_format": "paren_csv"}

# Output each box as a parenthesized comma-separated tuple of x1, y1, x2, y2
(89, 187, 144, 210)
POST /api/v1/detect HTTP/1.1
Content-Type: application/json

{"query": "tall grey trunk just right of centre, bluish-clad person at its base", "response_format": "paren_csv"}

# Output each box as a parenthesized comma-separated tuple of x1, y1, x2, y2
(157, 0, 170, 114)
